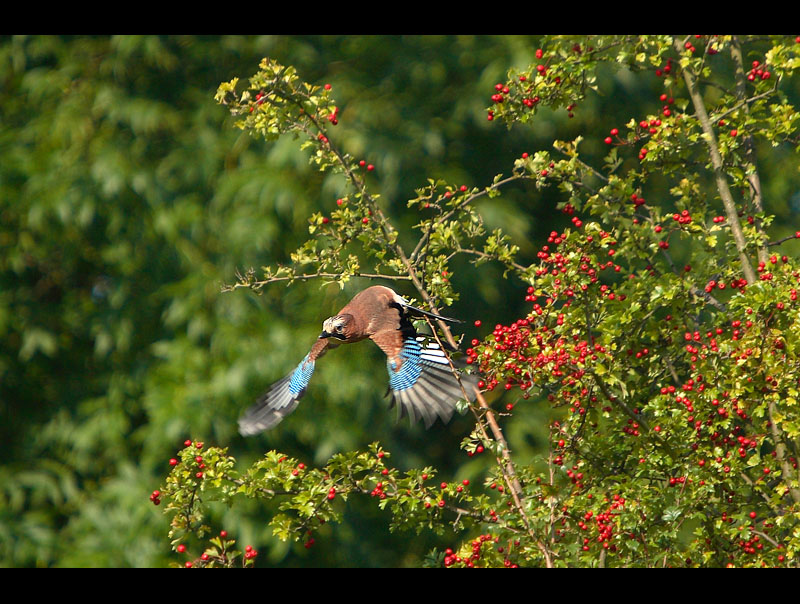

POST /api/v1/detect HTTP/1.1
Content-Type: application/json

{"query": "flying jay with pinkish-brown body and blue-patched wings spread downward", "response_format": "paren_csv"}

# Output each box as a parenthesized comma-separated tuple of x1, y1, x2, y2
(239, 285, 477, 436)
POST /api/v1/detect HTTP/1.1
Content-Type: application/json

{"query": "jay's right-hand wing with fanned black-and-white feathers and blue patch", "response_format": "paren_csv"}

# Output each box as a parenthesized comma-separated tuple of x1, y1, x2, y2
(371, 330, 477, 428)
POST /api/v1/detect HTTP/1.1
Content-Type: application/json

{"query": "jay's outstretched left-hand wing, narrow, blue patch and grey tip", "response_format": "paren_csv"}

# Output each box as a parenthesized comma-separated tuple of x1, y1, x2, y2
(239, 338, 335, 436)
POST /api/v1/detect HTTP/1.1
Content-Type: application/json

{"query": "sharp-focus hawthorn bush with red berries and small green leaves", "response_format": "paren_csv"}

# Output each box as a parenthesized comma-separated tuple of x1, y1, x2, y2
(158, 36, 800, 567)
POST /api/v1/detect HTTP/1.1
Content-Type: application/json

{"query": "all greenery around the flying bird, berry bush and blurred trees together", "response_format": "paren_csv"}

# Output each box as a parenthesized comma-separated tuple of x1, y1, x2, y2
(0, 36, 800, 567)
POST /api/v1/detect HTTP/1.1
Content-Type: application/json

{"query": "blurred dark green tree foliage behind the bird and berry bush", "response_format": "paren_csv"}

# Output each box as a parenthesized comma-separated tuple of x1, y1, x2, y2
(0, 36, 792, 567)
